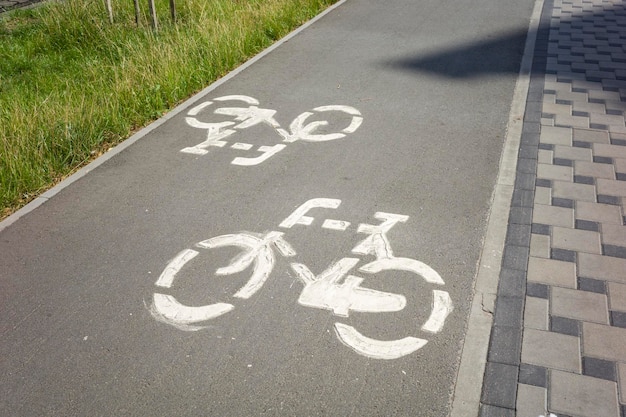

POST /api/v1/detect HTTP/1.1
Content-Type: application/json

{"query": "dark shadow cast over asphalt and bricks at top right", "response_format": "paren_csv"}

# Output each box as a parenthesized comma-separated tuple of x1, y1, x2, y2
(385, 1, 626, 88)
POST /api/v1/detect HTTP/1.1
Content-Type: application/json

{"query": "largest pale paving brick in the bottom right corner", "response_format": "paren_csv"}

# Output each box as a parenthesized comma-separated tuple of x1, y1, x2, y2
(548, 371, 619, 417)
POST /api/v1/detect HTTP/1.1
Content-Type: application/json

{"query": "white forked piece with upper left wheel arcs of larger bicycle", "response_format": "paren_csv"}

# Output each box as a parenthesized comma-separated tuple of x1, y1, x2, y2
(197, 232, 296, 299)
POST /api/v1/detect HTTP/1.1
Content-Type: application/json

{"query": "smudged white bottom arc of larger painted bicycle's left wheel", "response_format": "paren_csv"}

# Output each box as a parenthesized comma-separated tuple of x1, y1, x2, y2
(150, 293, 235, 331)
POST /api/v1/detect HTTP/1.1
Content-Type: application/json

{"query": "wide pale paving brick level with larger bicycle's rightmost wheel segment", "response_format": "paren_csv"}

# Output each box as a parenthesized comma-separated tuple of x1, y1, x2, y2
(550, 287, 609, 324)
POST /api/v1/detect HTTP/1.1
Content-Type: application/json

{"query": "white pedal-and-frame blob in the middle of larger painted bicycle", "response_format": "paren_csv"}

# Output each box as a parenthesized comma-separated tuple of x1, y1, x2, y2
(291, 258, 406, 317)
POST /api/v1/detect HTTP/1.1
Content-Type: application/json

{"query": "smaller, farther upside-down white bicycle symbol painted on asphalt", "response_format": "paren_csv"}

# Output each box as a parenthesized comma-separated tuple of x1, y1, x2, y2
(180, 95, 363, 166)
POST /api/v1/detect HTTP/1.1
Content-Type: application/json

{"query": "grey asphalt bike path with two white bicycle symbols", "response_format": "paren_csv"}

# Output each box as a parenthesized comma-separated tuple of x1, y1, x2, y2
(0, 0, 534, 416)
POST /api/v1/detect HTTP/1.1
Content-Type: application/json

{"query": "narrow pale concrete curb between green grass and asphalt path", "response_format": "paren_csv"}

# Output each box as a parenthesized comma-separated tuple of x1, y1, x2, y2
(0, 0, 348, 231)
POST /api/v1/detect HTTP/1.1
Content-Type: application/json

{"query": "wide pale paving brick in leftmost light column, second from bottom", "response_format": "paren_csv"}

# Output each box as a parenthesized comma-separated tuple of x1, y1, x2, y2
(522, 328, 582, 373)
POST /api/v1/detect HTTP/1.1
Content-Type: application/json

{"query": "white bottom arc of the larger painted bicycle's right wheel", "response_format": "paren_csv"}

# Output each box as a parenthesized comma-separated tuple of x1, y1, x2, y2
(335, 323, 428, 359)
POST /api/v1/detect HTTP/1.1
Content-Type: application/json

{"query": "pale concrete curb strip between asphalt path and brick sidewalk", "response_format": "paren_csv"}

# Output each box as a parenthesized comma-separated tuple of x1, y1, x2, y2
(449, 0, 543, 417)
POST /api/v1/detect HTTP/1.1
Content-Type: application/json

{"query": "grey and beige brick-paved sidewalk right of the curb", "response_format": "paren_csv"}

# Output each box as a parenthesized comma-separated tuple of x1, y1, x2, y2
(481, 0, 626, 417)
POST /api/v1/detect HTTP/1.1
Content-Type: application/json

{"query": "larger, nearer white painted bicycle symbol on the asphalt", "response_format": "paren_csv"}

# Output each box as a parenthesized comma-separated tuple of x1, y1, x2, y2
(150, 198, 453, 359)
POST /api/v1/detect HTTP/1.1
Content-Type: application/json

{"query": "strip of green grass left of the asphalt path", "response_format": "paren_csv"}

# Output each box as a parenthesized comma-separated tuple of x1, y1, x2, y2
(0, 0, 337, 218)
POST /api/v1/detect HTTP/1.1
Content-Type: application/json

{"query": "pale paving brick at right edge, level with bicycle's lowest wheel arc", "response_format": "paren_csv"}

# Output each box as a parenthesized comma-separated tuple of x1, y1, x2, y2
(584, 322, 626, 362)
